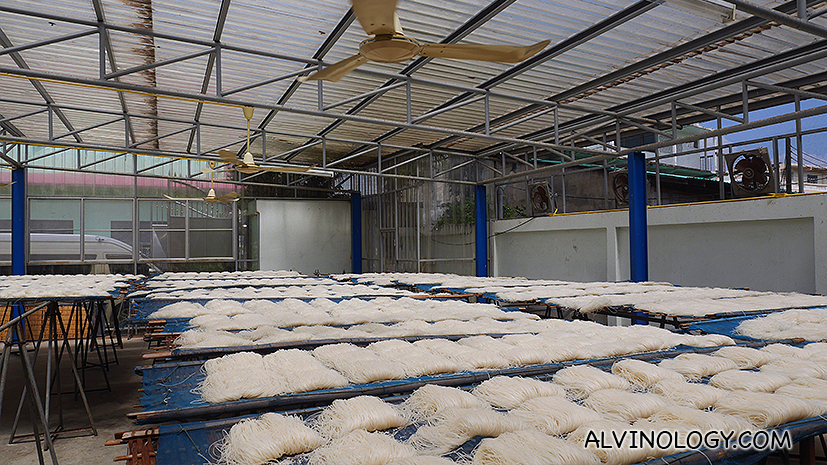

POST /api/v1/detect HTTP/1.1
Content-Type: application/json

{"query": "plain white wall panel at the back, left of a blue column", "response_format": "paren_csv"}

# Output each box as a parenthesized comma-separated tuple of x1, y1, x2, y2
(256, 199, 352, 274)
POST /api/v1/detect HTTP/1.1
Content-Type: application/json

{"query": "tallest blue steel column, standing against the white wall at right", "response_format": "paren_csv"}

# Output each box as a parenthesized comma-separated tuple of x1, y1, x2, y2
(629, 152, 649, 283)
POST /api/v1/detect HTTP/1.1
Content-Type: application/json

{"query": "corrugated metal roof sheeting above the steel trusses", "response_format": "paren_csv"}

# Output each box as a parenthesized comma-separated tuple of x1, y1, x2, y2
(0, 0, 827, 173)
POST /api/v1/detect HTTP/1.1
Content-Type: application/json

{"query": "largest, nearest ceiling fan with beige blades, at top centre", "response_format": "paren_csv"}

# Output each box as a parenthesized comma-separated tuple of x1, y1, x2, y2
(297, 0, 550, 82)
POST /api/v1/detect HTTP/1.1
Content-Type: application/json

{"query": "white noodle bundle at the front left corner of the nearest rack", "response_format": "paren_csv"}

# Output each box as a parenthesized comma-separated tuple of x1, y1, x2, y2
(218, 413, 324, 465)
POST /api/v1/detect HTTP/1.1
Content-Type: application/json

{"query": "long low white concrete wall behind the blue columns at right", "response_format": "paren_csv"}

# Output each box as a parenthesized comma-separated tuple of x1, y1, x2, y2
(490, 194, 827, 294)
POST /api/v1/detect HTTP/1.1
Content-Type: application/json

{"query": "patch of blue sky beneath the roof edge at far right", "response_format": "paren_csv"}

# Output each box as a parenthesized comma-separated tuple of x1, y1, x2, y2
(701, 99, 827, 164)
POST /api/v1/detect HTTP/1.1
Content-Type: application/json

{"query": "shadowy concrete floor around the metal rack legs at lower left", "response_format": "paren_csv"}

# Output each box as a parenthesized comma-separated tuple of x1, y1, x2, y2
(0, 337, 146, 465)
